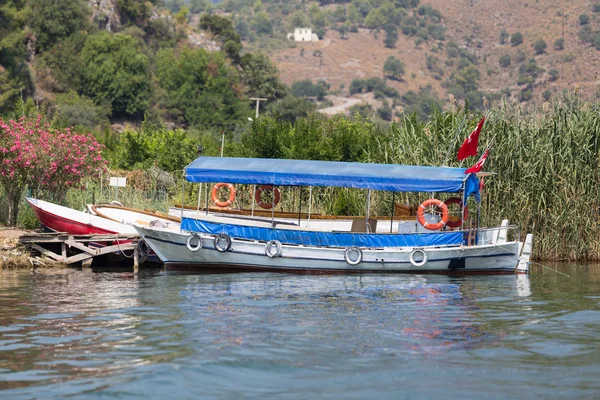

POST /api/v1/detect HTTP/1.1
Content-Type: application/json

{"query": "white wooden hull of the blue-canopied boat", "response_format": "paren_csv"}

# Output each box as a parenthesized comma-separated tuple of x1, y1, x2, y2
(136, 225, 527, 274)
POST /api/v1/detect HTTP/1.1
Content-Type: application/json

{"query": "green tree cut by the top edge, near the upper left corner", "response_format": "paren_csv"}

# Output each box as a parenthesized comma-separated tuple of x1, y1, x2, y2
(29, 0, 89, 51)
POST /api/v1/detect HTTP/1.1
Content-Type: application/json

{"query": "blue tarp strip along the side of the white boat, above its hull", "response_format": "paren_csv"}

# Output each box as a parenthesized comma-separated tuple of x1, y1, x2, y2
(181, 218, 463, 247)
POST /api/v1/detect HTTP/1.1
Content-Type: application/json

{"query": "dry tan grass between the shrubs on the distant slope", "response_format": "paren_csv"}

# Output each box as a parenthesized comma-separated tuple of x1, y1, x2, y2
(271, 0, 600, 104)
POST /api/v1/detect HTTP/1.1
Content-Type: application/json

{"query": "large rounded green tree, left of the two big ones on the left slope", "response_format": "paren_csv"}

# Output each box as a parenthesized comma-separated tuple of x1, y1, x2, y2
(81, 32, 150, 116)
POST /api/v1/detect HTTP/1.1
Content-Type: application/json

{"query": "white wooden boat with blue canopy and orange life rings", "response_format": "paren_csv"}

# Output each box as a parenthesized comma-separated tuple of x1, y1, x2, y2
(135, 157, 533, 274)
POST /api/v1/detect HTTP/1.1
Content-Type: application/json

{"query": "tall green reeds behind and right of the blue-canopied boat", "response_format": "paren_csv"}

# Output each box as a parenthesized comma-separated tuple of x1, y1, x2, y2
(367, 98, 600, 260)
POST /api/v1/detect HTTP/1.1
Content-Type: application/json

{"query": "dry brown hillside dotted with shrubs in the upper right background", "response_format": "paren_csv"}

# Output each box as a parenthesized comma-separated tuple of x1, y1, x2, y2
(270, 0, 600, 112)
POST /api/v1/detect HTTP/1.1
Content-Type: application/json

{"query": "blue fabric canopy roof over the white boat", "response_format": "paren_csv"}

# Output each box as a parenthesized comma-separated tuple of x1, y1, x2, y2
(185, 157, 479, 194)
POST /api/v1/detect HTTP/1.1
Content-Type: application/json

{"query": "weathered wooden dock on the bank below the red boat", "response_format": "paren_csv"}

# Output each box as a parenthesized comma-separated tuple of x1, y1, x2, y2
(19, 232, 154, 272)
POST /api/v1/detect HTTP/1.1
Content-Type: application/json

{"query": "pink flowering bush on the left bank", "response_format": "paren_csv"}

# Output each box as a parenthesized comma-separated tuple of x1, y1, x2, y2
(0, 116, 107, 226)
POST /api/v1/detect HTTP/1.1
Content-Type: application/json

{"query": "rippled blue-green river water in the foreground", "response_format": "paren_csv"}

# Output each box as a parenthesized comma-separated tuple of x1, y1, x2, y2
(0, 265, 600, 400)
